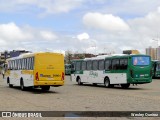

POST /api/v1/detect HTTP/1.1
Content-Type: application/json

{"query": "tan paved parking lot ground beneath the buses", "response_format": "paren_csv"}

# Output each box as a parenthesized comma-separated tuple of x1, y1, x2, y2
(0, 76, 160, 119)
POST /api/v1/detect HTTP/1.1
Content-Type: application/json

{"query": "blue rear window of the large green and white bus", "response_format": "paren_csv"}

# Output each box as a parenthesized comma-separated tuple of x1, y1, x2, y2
(132, 56, 150, 66)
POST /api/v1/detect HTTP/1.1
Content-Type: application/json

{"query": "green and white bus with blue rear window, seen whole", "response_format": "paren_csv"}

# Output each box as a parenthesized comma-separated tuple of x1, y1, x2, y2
(71, 54, 152, 88)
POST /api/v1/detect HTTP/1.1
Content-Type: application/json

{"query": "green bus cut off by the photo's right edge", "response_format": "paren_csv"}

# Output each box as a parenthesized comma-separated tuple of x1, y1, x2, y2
(152, 60, 160, 78)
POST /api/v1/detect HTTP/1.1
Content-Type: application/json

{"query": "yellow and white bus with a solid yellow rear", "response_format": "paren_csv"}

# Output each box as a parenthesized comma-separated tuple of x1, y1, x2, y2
(4, 52, 65, 91)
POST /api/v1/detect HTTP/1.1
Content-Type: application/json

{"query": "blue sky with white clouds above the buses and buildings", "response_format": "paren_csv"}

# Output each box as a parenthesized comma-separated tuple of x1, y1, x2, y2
(0, 0, 160, 54)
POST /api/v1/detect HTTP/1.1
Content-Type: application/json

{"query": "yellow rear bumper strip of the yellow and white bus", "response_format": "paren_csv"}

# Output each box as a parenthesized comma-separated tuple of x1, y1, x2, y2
(34, 81, 64, 86)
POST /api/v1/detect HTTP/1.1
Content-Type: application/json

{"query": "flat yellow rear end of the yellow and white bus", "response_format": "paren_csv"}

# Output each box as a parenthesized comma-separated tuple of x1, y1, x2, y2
(34, 53, 64, 86)
